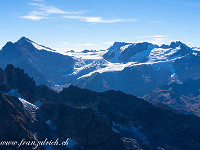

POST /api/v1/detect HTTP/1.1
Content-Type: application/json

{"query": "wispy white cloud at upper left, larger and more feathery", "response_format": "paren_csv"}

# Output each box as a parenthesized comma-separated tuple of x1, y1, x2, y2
(20, 0, 84, 20)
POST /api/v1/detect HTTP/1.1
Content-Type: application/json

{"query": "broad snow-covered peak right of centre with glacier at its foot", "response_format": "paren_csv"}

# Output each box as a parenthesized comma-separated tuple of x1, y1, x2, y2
(73, 42, 197, 79)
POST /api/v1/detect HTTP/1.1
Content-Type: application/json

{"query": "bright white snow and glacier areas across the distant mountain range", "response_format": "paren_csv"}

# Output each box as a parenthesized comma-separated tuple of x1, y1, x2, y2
(24, 41, 200, 83)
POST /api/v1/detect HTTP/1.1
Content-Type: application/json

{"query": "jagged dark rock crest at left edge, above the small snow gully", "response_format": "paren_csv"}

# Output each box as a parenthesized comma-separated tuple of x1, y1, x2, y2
(0, 65, 56, 102)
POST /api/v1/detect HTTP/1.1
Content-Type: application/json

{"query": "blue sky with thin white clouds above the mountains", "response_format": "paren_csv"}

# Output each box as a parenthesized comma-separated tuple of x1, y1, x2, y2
(0, 0, 200, 52)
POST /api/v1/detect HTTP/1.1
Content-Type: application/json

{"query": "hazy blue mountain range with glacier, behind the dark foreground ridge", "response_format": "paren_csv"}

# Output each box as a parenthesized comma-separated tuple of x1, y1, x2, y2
(0, 37, 200, 116)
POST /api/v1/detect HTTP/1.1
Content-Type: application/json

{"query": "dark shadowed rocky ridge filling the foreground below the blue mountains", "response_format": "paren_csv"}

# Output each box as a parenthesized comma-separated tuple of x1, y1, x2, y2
(0, 66, 200, 150)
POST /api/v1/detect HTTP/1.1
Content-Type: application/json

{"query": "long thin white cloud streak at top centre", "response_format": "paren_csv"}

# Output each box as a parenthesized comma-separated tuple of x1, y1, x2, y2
(64, 16, 138, 23)
